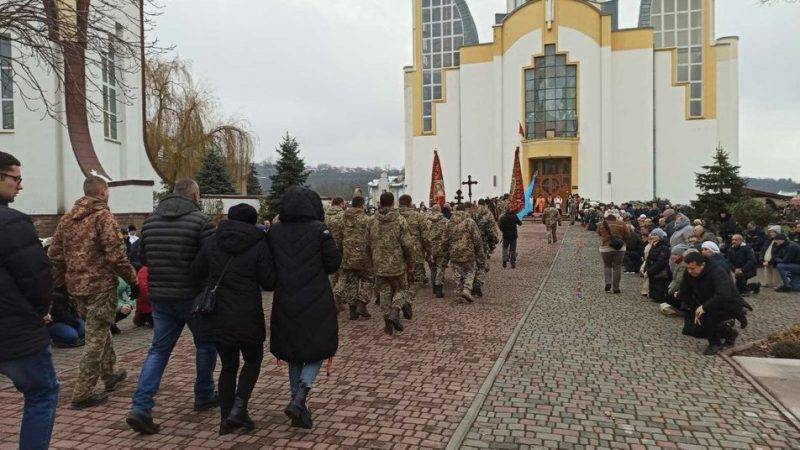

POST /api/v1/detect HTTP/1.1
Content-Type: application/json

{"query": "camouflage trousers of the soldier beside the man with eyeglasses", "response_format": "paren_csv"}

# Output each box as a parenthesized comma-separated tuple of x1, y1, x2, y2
(72, 289, 117, 402)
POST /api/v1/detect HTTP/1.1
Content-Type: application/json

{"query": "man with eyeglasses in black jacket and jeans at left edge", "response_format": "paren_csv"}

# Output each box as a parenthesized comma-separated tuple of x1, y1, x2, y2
(0, 152, 58, 449)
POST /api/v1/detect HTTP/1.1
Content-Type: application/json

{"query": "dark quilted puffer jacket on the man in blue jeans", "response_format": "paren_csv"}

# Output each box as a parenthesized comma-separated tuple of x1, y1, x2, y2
(140, 195, 214, 303)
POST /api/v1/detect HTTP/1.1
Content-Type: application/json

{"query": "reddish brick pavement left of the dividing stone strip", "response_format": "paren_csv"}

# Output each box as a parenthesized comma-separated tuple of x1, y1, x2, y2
(0, 223, 564, 449)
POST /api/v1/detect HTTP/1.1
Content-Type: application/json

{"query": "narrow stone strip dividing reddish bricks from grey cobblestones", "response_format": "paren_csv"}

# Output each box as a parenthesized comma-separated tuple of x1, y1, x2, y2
(446, 227, 569, 450)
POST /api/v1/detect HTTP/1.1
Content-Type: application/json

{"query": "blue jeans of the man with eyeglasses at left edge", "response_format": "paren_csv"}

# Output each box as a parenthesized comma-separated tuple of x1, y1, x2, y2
(0, 345, 58, 450)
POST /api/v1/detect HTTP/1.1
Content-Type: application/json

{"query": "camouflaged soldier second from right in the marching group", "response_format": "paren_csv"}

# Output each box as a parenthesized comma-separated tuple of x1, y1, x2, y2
(447, 205, 486, 303)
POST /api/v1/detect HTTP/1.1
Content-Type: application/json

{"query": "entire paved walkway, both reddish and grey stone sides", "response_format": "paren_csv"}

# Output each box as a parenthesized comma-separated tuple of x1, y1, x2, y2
(0, 223, 800, 449)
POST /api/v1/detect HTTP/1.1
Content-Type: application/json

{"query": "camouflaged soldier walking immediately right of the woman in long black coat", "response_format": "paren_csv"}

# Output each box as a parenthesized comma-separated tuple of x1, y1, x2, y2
(332, 197, 372, 320)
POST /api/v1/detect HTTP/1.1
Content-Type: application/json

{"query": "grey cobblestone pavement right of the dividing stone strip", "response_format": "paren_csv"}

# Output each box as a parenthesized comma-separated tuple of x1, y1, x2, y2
(464, 227, 800, 449)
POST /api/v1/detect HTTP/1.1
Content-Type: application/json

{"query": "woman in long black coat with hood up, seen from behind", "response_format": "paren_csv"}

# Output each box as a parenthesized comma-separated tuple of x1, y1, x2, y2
(267, 187, 342, 428)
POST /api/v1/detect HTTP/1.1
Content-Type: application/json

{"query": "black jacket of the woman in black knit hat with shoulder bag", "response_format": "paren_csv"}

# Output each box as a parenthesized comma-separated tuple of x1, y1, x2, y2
(192, 220, 275, 347)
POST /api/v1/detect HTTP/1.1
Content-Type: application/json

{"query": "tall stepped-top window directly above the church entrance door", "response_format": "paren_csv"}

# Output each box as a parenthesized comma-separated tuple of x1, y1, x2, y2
(525, 44, 578, 139)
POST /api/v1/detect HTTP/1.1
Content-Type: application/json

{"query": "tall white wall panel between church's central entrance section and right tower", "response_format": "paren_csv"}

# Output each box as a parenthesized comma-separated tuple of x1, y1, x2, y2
(611, 49, 653, 203)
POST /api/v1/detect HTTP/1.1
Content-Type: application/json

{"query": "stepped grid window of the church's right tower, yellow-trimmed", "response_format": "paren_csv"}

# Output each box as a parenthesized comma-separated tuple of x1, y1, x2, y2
(650, 0, 703, 117)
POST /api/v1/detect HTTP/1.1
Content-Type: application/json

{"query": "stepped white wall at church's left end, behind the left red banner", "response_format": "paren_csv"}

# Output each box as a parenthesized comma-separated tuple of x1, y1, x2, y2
(406, 70, 461, 203)
